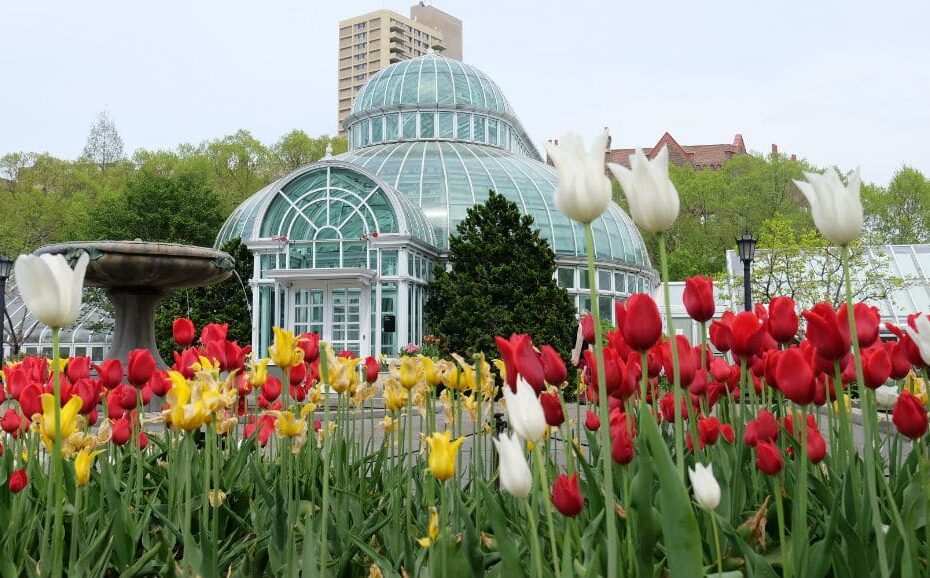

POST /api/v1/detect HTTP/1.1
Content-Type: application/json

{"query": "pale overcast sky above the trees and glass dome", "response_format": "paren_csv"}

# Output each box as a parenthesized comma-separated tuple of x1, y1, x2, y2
(0, 0, 930, 184)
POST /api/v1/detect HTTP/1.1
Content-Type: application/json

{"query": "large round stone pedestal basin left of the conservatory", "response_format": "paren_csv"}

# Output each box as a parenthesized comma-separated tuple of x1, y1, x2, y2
(35, 239, 235, 369)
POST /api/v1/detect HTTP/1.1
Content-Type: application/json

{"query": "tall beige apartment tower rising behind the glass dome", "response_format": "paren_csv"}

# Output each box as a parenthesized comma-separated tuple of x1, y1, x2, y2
(337, 2, 462, 135)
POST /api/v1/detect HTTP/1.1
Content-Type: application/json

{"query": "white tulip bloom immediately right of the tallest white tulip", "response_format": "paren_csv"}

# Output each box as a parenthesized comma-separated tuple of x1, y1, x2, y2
(607, 146, 680, 233)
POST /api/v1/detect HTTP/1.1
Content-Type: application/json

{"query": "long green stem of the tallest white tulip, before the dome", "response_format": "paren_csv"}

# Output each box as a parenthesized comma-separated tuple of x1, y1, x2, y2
(580, 223, 617, 578)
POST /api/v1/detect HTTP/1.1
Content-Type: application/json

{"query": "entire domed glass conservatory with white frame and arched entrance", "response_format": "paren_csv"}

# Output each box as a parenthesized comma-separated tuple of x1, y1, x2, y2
(216, 54, 657, 357)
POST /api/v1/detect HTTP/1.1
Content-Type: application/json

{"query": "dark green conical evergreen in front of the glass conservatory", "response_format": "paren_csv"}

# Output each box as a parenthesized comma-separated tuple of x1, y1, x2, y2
(426, 191, 575, 353)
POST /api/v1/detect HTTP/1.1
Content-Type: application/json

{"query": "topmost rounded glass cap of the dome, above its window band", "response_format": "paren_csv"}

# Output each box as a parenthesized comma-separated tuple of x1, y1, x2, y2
(352, 54, 513, 116)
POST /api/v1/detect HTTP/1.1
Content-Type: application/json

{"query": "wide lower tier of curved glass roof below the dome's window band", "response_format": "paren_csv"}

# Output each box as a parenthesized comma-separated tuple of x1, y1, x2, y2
(337, 141, 650, 267)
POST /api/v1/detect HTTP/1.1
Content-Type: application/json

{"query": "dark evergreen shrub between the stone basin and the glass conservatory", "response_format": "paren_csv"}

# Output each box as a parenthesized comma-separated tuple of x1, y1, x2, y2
(155, 239, 253, 356)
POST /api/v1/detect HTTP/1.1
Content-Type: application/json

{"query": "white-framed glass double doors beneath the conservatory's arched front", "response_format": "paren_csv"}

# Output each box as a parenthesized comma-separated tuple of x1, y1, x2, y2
(291, 283, 371, 357)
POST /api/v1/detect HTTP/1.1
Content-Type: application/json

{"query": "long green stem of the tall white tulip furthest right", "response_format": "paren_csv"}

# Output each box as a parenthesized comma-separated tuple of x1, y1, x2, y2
(841, 245, 890, 578)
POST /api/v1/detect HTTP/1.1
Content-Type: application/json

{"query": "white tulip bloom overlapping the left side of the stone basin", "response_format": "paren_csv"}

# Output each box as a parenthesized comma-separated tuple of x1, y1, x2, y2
(15, 252, 90, 329)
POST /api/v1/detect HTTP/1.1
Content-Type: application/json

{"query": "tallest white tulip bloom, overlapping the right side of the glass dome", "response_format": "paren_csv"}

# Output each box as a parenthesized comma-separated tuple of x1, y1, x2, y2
(546, 132, 612, 223)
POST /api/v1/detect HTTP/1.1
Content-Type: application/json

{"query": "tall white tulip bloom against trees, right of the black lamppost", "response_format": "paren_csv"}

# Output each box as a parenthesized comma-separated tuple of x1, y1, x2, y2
(794, 168, 862, 245)
